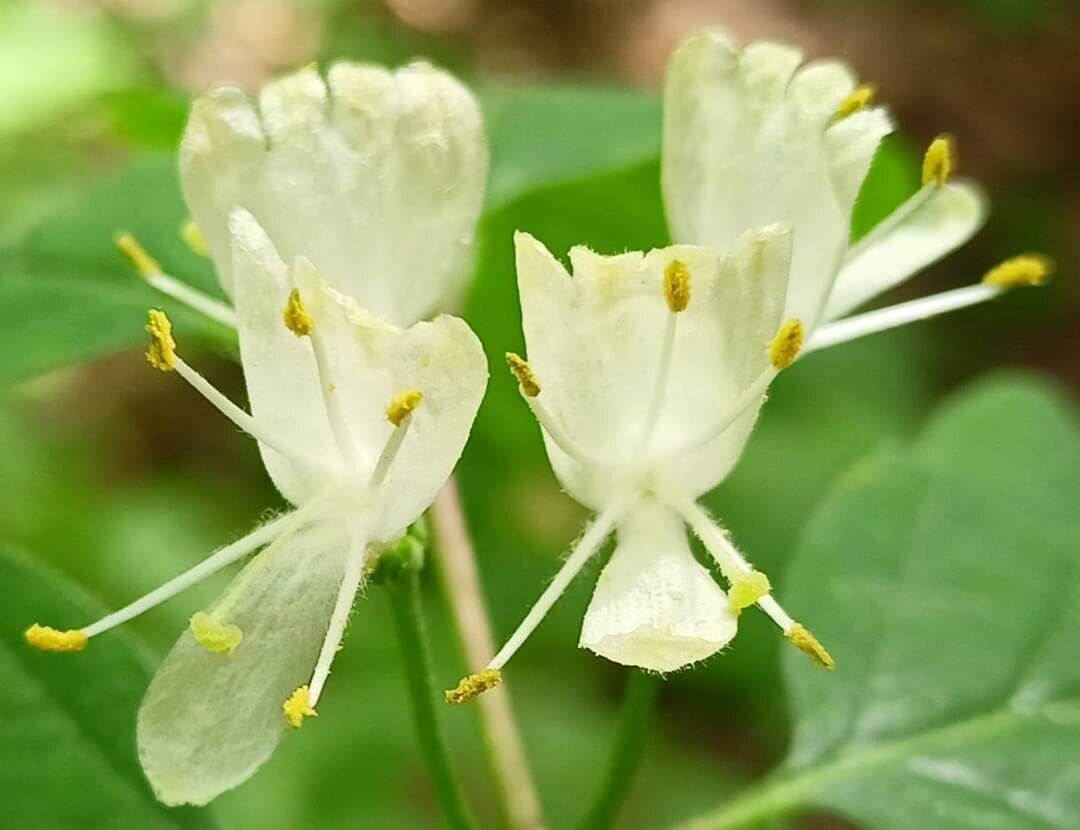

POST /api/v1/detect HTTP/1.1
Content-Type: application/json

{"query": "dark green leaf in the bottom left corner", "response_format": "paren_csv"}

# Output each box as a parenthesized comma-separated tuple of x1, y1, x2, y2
(0, 553, 216, 830)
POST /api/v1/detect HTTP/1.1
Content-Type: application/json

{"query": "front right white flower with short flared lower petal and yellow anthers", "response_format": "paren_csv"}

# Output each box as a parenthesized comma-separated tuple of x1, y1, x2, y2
(447, 224, 832, 703)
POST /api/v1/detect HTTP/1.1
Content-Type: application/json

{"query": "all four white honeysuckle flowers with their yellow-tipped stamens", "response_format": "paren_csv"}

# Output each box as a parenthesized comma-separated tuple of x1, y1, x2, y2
(27, 31, 1049, 803)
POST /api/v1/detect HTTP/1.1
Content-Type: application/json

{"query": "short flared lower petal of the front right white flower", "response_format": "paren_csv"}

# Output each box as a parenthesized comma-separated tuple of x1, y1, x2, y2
(580, 503, 738, 671)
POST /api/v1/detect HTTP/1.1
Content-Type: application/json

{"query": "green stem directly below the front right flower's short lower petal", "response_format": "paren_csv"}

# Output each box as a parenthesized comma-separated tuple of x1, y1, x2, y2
(581, 669, 661, 830)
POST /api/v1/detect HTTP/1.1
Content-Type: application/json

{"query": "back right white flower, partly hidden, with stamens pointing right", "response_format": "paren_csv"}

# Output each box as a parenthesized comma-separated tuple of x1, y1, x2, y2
(662, 29, 1051, 352)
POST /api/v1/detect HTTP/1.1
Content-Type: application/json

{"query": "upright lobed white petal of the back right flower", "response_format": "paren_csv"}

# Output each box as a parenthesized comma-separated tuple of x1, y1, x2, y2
(663, 30, 892, 329)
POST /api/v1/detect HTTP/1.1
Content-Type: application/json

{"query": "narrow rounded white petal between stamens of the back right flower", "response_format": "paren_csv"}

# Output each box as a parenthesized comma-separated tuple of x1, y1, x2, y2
(823, 181, 987, 321)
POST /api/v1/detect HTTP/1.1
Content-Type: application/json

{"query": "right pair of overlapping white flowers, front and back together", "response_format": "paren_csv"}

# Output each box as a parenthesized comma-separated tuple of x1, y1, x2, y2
(447, 31, 1049, 703)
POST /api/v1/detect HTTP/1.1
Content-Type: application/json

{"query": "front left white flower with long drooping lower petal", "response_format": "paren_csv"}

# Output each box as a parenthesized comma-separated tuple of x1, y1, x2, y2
(27, 209, 487, 804)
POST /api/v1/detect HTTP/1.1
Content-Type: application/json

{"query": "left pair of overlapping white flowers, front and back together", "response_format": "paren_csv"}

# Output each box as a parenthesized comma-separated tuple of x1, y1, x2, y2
(26, 66, 487, 804)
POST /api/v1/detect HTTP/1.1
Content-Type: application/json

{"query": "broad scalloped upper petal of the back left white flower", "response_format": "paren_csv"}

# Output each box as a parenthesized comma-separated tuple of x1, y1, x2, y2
(180, 63, 487, 325)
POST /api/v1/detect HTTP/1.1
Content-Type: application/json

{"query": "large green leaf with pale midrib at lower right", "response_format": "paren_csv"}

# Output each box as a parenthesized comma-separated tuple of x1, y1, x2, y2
(690, 371, 1080, 830)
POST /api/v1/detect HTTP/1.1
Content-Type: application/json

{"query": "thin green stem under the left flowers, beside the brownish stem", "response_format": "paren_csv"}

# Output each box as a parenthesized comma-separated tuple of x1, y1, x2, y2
(387, 568, 476, 830)
